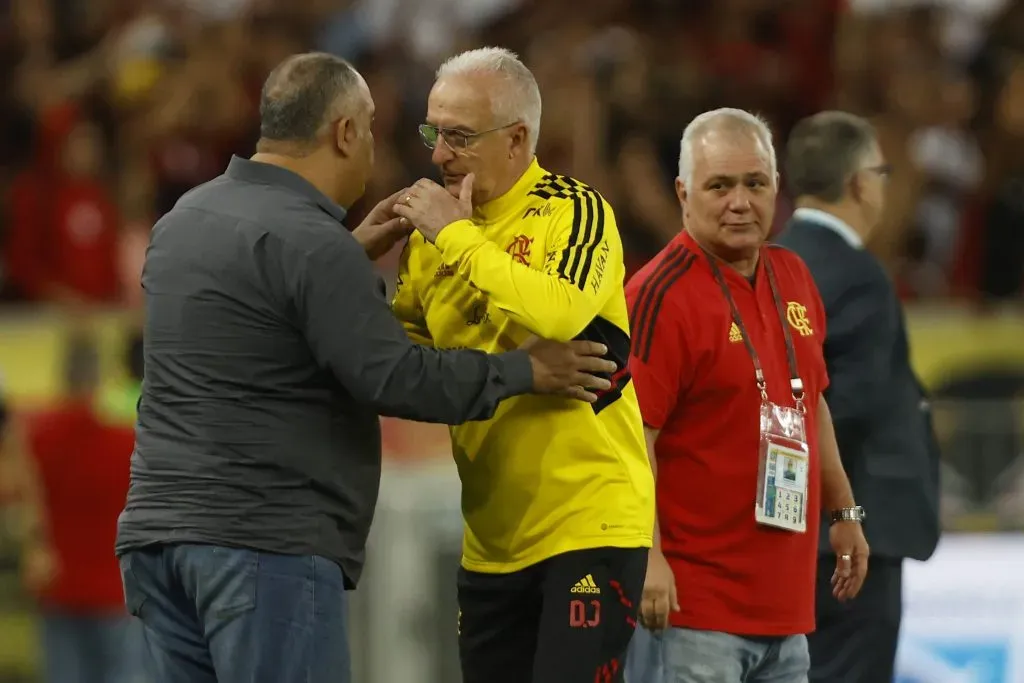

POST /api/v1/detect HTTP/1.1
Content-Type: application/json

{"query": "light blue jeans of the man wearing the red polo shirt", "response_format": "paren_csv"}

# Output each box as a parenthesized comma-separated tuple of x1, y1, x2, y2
(626, 627, 811, 683)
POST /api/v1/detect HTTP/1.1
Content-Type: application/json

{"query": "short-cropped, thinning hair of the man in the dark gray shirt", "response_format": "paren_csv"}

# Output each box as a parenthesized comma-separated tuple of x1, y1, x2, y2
(259, 52, 366, 146)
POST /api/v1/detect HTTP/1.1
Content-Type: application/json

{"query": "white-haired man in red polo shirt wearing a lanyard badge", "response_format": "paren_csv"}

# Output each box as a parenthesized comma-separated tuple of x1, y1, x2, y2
(627, 110, 868, 683)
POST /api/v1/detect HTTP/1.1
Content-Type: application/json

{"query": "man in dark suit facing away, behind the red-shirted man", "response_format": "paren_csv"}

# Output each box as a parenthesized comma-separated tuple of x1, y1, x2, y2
(779, 112, 939, 683)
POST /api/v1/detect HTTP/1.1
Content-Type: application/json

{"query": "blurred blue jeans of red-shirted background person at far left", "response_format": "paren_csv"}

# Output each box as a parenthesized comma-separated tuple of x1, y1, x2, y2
(40, 607, 141, 683)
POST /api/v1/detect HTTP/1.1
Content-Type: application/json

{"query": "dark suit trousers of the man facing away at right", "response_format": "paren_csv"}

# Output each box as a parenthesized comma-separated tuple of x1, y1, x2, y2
(807, 556, 903, 683)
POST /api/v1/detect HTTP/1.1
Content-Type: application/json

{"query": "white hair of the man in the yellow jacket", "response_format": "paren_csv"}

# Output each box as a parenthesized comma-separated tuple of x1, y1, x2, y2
(437, 47, 541, 154)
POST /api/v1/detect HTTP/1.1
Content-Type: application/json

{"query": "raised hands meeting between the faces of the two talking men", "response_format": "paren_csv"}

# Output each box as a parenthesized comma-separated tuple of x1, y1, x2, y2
(352, 173, 473, 259)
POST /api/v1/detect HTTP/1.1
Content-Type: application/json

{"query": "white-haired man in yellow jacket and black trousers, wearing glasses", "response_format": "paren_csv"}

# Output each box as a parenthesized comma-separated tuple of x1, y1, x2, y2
(393, 48, 654, 683)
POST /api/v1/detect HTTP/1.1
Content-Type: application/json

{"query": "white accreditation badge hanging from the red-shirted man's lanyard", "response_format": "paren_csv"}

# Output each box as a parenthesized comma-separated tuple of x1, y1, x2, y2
(754, 400, 811, 533)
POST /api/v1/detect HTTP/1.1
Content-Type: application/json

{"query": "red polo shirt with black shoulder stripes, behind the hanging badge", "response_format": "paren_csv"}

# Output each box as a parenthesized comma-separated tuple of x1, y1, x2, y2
(626, 231, 828, 636)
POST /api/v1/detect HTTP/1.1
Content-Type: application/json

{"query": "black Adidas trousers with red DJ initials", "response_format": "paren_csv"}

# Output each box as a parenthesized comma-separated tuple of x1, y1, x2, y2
(459, 548, 647, 683)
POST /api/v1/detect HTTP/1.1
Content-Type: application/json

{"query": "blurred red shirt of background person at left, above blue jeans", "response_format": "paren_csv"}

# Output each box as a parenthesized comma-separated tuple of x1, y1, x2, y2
(27, 403, 135, 612)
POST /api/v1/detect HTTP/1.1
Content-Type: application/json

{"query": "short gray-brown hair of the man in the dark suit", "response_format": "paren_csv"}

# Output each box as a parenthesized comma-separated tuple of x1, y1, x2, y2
(785, 112, 876, 204)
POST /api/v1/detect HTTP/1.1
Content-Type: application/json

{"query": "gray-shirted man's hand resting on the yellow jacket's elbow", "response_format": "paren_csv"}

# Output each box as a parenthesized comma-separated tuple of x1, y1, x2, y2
(520, 337, 616, 403)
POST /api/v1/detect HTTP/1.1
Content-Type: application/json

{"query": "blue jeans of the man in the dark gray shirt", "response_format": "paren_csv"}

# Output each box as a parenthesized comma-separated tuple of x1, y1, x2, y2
(121, 545, 351, 683)
